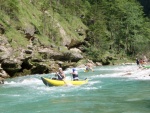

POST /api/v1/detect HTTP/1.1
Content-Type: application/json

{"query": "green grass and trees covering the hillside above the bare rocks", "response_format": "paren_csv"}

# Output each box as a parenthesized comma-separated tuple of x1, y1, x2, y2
(0, 0, 150, 61)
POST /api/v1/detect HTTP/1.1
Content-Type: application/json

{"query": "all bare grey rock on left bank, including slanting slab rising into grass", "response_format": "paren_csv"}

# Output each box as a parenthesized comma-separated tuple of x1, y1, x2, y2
(0, 11, 90, 77)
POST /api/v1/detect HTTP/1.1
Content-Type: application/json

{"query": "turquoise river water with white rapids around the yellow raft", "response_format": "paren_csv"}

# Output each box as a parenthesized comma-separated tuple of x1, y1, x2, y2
(0, 65, 150, 113)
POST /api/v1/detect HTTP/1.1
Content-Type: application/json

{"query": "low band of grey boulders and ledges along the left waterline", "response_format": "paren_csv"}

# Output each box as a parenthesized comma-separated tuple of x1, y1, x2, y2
(0, 35, 84, 77)
